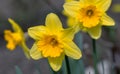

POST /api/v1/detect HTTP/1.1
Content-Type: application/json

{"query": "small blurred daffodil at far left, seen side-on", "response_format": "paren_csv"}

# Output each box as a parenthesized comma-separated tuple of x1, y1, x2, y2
(4, 18, 29, 58)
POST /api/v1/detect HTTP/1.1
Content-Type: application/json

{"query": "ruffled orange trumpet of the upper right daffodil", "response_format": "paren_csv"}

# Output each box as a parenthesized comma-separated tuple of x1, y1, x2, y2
(78, 5, 102, 28)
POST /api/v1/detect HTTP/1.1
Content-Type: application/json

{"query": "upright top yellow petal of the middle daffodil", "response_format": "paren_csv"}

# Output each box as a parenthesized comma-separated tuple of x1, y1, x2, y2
(45, 13, 63, 33)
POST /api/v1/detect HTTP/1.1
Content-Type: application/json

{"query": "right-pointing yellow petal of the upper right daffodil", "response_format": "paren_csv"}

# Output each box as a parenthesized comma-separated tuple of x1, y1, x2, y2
(101, 14, 115, 26)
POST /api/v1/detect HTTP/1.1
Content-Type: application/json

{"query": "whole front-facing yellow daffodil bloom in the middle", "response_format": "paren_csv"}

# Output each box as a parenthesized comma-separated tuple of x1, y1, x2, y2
(28, 13, 82, 71)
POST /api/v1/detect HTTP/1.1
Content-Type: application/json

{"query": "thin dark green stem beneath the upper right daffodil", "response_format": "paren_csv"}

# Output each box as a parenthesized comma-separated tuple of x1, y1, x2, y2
(92, 39, 98, 74)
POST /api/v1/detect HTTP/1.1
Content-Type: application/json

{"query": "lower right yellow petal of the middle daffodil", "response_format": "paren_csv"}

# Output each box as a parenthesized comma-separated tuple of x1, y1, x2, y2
(63, 41, 82, 59)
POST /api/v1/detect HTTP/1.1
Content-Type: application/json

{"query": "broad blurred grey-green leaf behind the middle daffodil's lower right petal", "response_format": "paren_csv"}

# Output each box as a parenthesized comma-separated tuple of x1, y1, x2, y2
(69, 32, 85, 74)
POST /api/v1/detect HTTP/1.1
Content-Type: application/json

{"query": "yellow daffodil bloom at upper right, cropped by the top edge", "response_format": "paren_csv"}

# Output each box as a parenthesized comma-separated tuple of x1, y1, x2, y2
(64, 0, 115, 39)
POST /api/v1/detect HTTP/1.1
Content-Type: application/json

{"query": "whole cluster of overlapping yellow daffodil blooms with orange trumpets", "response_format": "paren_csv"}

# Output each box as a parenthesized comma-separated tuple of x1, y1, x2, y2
(4, 0, 115, 71)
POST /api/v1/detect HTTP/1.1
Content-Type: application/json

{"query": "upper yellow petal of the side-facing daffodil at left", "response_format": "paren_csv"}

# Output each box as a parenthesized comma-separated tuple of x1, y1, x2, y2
(8, 18, 24, 35)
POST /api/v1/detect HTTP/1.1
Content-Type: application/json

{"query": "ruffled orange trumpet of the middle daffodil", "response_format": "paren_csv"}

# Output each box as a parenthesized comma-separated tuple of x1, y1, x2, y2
(37, 35, 63, 57)
